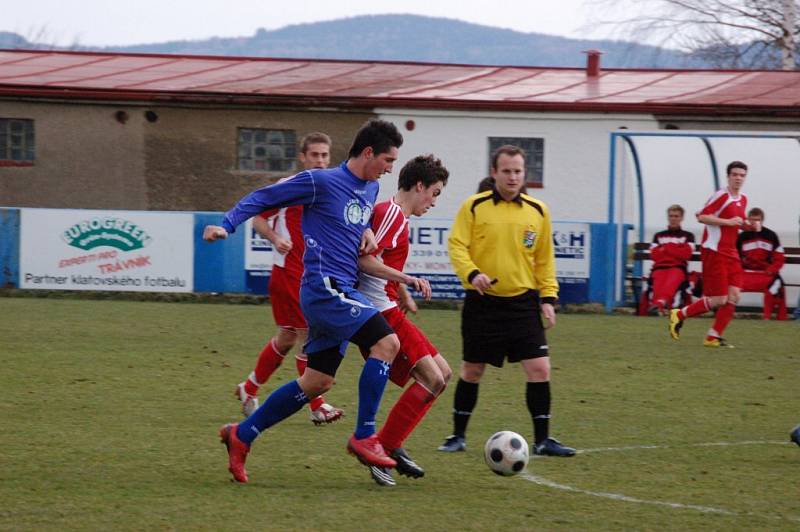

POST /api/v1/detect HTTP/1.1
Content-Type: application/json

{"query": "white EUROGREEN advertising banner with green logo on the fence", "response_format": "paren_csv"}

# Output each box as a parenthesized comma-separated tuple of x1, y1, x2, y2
(19, 209, 194, 292)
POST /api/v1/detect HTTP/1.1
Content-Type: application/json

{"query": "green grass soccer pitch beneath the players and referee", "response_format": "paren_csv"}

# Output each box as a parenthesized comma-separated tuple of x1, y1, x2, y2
(0, 298, 800, 530)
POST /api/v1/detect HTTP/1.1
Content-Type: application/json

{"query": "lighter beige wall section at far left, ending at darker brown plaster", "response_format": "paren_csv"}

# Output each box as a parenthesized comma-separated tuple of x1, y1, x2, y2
(0, 100, 147, 209)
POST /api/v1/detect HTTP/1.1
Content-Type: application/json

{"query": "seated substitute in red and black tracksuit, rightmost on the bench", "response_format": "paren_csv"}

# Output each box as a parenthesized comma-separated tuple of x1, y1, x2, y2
(736, 207, 787, 320)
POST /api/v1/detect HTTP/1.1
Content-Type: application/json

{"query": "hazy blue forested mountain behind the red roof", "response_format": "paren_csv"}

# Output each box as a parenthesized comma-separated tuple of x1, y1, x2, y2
(6, 15, 707, 68)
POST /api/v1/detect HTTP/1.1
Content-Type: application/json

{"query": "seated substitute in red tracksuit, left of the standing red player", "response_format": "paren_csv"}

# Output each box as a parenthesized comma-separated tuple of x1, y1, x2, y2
(639, 205, 694, 316)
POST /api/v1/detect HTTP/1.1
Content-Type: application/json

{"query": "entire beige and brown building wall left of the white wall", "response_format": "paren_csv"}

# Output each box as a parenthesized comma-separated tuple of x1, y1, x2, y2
(0, 100, 373, 211)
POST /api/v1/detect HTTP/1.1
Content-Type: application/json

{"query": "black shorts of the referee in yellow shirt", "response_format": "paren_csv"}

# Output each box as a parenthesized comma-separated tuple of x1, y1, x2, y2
(461, 290, 548, 368)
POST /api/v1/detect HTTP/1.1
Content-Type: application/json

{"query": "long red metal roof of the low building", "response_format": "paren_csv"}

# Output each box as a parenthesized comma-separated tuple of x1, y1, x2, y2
(0, 50, 800, 116)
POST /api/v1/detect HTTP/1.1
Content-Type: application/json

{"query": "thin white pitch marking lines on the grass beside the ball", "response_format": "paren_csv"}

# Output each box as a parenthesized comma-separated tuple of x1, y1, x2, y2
(519, 441, 800, 522)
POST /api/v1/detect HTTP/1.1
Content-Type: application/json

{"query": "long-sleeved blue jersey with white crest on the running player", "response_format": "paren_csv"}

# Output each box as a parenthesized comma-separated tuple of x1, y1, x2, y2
(222, 163, 378, 287)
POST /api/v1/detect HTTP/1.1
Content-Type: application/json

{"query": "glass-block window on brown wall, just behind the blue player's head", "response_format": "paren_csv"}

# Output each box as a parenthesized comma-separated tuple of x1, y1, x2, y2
(238, 128, 297, 172)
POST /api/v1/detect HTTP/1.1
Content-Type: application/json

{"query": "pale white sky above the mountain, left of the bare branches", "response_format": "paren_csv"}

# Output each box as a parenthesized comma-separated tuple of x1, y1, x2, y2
(0, 0, 603, 46)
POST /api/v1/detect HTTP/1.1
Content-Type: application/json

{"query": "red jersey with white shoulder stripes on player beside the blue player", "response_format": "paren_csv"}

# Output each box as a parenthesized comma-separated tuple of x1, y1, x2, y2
(358, 198, 408, 312)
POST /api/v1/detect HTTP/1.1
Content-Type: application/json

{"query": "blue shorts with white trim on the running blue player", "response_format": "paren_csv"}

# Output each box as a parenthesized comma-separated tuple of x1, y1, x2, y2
(300, 277, 379, 355)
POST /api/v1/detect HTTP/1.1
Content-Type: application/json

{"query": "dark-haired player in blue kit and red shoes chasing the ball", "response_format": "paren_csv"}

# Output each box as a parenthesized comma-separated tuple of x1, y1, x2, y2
(203, 119, 412, 482)
